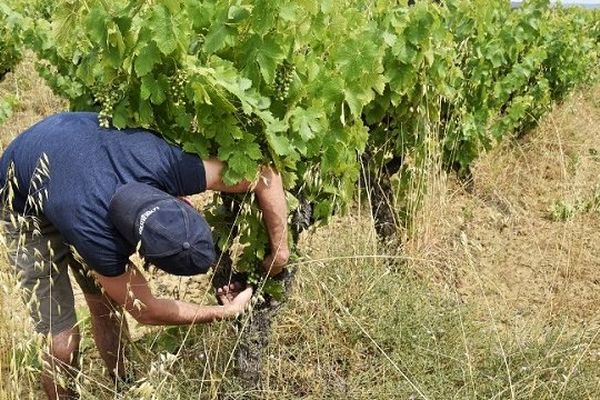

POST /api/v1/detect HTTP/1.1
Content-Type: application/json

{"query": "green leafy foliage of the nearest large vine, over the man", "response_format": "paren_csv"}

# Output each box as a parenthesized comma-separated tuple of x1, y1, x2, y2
(14, 0, 385, 294)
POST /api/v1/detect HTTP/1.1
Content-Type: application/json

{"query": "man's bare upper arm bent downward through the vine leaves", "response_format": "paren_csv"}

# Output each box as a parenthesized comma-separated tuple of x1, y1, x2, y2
(204, 159, 290, 276)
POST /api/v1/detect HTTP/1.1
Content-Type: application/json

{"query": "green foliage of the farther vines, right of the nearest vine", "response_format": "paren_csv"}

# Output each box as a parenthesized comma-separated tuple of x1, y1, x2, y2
(365, 0, 600, 228)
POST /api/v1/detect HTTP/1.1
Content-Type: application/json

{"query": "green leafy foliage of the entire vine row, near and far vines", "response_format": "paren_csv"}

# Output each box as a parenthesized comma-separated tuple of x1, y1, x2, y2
(9, 0, 600, 290)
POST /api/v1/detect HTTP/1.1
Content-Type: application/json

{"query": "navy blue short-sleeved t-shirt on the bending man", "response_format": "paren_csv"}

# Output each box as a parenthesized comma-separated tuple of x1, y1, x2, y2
(0, 113, 206, 276)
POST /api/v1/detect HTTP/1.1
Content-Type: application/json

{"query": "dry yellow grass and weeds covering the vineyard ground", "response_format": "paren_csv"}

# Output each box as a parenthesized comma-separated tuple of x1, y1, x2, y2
(0, 57, 600, 400)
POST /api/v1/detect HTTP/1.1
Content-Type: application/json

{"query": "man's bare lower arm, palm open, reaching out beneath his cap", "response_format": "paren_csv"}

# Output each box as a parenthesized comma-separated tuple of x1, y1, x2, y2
(96, 264, 252, 325)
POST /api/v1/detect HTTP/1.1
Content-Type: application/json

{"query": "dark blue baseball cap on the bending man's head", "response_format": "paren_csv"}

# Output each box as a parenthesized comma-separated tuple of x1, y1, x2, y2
(109, 182, 215, 276)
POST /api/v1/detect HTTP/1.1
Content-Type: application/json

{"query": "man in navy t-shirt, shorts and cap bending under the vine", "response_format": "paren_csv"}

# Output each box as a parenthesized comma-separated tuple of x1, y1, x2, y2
(0, 113, 289, 399)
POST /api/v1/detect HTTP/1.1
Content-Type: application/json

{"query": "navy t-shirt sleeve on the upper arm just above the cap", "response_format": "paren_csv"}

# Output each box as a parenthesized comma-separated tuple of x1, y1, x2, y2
(165, 146, 206, 196)
